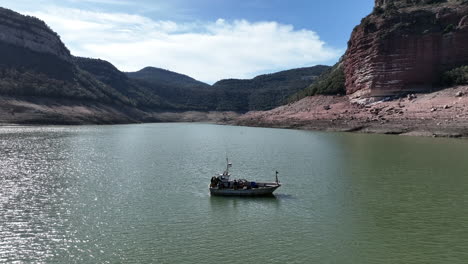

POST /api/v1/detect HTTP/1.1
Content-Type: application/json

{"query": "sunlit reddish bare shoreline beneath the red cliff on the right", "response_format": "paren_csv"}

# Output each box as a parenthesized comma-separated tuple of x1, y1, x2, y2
(236, 86, 468, 137)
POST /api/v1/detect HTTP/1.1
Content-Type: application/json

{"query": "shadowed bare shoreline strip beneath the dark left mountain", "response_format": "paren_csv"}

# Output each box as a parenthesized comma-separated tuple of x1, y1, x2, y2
(0, 96, 240, 125)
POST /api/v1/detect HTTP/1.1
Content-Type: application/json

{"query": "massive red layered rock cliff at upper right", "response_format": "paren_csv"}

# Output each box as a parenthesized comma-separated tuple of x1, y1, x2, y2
(344, 0, 468, 96)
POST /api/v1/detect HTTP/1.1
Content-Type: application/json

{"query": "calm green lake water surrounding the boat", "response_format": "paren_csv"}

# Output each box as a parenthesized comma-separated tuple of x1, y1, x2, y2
(0, 124, 468, 264)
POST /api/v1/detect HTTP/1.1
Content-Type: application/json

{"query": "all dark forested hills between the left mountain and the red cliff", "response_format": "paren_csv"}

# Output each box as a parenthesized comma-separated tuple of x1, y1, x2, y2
(75, 58, 330, 112)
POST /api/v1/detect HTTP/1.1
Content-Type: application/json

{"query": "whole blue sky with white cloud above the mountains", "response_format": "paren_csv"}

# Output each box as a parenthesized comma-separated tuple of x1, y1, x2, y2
(0, 0, 374, 84)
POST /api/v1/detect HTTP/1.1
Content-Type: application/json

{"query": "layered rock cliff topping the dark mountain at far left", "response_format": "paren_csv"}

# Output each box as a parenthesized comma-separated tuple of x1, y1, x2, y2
(0, 8, 71, 62)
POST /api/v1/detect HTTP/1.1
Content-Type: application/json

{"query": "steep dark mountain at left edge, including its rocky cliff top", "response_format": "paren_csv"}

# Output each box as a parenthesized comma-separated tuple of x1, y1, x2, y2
(0, 8, 144, 105)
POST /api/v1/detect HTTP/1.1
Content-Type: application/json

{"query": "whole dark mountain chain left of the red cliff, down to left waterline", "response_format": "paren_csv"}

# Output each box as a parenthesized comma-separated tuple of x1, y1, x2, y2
(0, 8, 328, 124)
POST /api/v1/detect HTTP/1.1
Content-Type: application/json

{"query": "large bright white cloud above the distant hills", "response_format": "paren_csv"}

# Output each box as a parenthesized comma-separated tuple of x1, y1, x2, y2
(28, 7, 342, 83)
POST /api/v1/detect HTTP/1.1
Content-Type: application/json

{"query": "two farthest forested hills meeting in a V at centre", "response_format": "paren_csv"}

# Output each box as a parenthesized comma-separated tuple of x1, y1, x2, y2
(126, 65, 330, 112)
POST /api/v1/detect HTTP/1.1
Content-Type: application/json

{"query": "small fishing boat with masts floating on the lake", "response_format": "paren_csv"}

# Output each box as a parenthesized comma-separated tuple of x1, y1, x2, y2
(210, 158, 281, 196)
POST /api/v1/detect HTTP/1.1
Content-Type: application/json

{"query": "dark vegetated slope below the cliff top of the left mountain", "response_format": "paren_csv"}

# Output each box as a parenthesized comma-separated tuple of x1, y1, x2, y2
(0, 43, 131, 104)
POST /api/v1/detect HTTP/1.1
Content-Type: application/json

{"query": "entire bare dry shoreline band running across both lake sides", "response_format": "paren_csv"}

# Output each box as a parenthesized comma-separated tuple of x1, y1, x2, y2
(0, 86, 468, 137)
